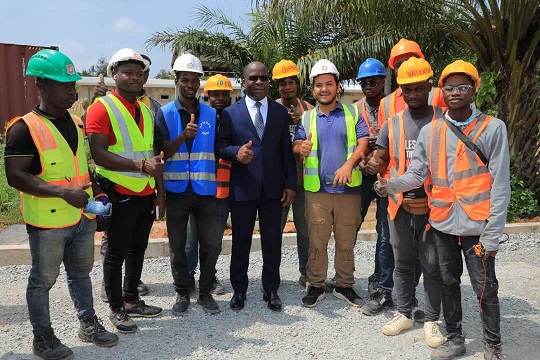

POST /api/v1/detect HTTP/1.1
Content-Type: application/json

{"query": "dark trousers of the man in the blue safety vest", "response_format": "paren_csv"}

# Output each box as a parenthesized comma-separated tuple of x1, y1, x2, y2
(166, 191, 218, 295)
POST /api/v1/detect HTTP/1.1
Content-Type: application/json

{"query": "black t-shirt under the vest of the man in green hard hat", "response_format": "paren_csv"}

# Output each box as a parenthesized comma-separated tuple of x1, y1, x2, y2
(4, 106, 78, 175)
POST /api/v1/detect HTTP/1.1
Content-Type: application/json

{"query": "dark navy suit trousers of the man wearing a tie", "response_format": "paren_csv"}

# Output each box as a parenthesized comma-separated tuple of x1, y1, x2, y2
(230, 190, 282, 293)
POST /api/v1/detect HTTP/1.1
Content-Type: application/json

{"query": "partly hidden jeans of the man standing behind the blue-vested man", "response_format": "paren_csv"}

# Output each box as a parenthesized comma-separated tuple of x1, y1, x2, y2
(186, 198, 230, 277)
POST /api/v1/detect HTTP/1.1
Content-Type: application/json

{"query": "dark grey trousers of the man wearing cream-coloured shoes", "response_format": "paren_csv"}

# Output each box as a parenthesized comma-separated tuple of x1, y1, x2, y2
(389, 207, 442, 321)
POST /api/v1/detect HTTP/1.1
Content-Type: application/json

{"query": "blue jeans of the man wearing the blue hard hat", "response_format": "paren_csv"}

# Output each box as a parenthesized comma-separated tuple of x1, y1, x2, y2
(360, 176, 394, 291)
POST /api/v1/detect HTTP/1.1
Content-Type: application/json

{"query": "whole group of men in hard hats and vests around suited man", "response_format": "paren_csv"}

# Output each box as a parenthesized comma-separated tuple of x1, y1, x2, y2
(5, 35, 510, 359)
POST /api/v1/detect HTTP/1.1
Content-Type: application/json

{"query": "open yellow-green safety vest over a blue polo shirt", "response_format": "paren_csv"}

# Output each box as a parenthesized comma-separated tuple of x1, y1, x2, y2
(302, 104, 362, 192)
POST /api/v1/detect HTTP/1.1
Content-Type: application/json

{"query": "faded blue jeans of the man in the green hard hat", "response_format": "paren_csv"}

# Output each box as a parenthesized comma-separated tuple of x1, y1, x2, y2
(26, 216, 96, 335)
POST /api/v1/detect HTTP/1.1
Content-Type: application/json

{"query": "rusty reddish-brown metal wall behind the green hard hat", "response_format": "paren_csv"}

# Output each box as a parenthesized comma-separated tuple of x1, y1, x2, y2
(0, 43, 58, 133)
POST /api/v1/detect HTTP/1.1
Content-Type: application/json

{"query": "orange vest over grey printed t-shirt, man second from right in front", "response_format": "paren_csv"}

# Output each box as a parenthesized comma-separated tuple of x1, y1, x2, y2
(385, 106, 443, 220)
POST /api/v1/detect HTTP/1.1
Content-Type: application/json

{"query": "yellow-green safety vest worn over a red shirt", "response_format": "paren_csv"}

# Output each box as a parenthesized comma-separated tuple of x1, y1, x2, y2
(96, 94, 155, 192)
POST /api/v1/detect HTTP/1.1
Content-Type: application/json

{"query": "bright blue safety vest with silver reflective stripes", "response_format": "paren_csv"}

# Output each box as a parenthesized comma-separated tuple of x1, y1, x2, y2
(161, 101, 217, 195)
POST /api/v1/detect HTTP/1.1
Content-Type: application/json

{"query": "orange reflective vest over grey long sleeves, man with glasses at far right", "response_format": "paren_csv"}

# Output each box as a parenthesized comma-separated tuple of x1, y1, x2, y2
(428, 114, 492, 221)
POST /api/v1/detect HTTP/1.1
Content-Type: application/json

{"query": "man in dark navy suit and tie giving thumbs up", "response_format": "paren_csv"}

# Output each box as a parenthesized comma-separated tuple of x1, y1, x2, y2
(216, 62, 296, 311)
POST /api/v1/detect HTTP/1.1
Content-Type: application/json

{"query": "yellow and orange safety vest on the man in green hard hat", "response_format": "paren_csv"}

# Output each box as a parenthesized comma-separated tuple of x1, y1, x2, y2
(15, 112, 95, 228)
